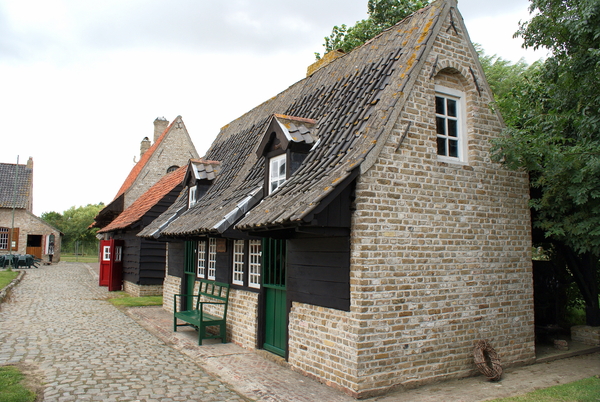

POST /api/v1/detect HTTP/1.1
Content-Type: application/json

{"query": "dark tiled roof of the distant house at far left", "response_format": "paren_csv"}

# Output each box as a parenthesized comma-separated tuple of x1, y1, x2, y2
(0, 163, 33, 209)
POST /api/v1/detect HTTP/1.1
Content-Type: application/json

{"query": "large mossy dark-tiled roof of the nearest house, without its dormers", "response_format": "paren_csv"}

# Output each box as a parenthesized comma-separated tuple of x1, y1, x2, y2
(151, 0, 456, 236)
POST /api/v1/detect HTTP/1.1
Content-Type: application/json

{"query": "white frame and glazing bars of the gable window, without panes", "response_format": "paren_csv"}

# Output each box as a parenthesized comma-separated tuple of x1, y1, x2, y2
(434, 85, 467, 163)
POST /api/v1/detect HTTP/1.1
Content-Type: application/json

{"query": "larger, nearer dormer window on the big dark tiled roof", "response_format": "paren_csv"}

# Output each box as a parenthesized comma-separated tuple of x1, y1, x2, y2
(256, 114, 317, 194)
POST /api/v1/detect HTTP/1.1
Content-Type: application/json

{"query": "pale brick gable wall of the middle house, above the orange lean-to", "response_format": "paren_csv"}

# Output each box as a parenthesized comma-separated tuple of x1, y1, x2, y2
(124, 117, 198, 208)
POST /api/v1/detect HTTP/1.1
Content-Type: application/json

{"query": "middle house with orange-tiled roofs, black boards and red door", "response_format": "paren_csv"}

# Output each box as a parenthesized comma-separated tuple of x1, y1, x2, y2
(92, 116, 198, 295)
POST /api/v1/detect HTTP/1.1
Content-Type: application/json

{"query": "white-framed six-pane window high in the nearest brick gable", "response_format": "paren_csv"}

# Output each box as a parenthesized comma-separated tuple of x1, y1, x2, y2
(435, 86, 466, 161)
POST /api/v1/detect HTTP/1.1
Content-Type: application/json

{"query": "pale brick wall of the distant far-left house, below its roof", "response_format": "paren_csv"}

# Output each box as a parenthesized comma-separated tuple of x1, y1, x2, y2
(0, 208, 61, 263)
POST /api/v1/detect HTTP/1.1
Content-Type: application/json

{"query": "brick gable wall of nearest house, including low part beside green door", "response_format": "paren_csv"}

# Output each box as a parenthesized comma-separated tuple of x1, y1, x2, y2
(289, 11, 535, 397)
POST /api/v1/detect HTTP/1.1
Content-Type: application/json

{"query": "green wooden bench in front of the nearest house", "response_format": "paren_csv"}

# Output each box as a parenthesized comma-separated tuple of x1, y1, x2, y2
(173, 279, 229, 345)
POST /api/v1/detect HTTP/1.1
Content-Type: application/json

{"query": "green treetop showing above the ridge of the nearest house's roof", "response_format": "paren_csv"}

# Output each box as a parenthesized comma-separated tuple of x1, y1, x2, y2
(315, 0, 429, 60)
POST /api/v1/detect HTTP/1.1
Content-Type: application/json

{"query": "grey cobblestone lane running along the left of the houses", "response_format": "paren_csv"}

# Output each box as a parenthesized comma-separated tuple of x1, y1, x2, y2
(0, 263, 247, 402)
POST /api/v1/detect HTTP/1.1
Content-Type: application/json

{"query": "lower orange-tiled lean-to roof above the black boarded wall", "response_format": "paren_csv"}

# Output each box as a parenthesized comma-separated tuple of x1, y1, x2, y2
(99, 166, 187, 233)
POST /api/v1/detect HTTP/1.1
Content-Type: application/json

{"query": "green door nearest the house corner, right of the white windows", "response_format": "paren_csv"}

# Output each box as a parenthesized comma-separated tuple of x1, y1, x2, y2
(262, 239, 287, 357)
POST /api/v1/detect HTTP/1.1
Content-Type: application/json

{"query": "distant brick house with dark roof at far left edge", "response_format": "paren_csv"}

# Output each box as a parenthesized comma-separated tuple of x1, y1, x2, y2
(0, 158, 62, 262)
